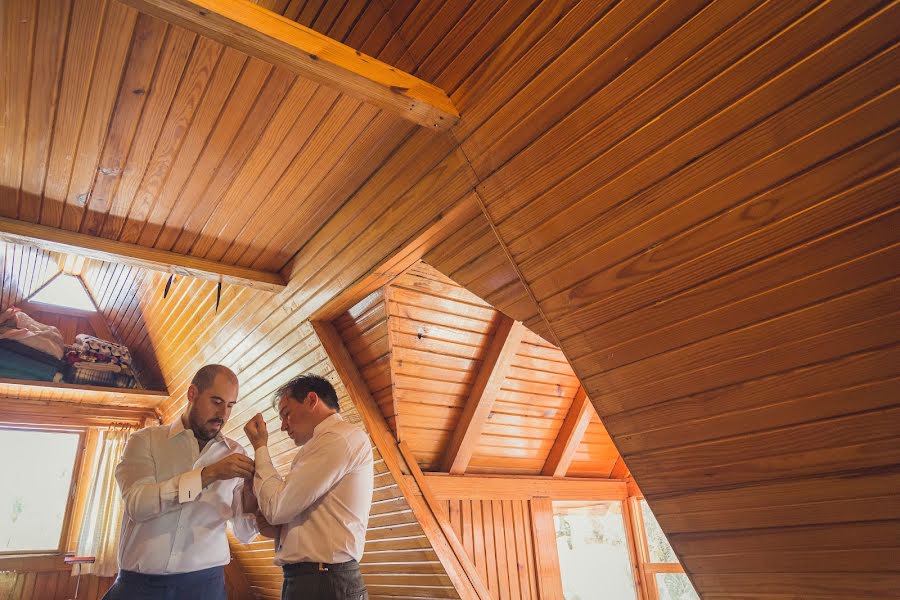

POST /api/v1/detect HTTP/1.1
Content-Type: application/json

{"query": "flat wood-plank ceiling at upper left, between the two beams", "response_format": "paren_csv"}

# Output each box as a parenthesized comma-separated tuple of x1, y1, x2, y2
(0, 0, 414, 271)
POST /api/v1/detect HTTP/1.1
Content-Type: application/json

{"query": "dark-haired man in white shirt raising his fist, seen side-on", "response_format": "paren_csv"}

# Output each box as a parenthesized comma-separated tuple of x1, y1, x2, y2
(244, 374, 374, 600)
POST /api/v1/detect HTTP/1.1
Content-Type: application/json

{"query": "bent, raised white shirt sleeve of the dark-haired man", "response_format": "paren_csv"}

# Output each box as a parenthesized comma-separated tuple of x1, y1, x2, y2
(253, 432, 352, 525)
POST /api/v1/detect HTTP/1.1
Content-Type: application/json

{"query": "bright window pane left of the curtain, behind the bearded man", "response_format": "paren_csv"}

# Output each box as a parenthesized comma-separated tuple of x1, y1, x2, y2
(0, 429, 78, 552)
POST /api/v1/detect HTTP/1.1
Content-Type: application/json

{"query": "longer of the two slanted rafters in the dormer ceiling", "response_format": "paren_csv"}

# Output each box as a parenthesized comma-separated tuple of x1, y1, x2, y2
(442, 314, 525, 475)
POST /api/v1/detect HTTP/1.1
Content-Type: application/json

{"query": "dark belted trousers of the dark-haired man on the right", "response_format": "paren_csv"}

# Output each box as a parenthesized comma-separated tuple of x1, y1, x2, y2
(281, 560, 369, 600)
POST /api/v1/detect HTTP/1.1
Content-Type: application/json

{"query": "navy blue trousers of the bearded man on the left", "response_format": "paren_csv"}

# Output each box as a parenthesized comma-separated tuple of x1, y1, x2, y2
(103, 567, 227, 600)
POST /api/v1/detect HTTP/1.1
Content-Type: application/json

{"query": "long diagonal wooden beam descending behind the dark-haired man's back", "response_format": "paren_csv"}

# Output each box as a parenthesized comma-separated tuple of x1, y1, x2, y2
(312, 321, 490, 600)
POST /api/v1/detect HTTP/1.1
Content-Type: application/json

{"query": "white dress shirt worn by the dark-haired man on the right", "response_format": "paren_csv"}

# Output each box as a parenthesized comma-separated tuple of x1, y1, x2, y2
(253, 413, 374, 565)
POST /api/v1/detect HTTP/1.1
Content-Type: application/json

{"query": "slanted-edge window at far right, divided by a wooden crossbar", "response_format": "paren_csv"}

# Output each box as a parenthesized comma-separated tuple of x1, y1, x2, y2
(631, 498, 700, 600)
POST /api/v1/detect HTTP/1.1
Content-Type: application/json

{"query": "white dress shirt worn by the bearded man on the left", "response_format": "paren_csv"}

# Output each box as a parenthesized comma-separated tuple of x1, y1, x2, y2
(116, 418, 258, 575)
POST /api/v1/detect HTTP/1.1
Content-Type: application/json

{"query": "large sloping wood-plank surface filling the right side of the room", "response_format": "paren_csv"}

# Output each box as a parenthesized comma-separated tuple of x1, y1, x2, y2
(366, 0, 900, 598)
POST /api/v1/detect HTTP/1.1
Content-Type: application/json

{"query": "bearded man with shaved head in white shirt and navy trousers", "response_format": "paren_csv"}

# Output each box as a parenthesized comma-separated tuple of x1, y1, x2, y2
(104, 365, 257, 600)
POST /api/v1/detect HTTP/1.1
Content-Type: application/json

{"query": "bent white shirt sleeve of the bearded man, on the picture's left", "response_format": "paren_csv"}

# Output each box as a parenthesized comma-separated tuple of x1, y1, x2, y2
(116, 434, 201, 522)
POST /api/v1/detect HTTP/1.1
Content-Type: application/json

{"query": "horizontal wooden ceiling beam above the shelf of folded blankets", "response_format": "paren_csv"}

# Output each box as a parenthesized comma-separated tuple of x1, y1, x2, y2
(0, 217, 285, 292)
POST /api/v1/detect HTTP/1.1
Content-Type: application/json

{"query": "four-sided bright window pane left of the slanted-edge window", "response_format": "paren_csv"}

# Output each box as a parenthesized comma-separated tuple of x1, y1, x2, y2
(553, 502, 636, 600)
